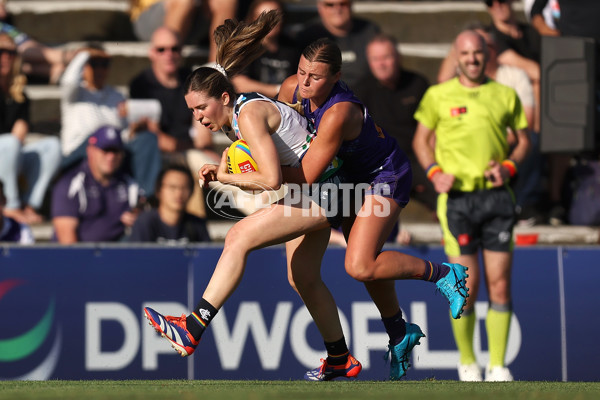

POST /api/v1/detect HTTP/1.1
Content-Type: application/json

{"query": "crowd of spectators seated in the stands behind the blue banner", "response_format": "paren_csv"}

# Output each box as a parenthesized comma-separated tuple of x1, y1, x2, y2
(0, 0, 600, 244)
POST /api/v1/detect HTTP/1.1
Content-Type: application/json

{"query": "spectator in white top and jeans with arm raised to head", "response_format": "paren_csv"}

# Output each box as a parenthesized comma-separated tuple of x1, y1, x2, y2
(60, 43, 160, 196)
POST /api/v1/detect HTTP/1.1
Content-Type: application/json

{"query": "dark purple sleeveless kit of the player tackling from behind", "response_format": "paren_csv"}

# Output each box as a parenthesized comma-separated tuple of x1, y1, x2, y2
(294, 81, 412, 206)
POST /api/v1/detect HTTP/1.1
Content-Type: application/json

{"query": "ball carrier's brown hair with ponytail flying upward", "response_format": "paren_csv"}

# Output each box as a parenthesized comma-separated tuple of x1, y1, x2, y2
(183, 10, 282, 98)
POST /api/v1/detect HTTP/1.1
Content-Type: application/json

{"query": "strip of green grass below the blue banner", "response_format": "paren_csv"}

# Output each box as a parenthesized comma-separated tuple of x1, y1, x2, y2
(0, 380, 600, 400)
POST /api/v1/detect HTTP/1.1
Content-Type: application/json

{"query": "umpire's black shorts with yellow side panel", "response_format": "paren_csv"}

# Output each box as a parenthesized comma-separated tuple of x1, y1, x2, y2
(437, 187, 516, 256)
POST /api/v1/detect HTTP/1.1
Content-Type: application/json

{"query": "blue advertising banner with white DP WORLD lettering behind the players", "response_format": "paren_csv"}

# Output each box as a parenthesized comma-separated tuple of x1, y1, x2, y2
(0, 245, 600, 381)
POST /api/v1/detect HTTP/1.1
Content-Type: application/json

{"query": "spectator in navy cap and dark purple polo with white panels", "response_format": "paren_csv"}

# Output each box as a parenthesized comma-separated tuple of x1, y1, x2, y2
(51, 126, 139, 244)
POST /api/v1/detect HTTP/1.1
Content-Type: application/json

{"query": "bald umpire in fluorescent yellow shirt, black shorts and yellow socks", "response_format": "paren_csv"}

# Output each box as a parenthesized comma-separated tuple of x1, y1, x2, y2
(413, 30, 529, 381)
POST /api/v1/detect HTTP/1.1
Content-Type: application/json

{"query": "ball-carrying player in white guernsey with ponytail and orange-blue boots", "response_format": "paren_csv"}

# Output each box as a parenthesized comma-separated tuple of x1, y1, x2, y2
(145, 11, 362, 380)
